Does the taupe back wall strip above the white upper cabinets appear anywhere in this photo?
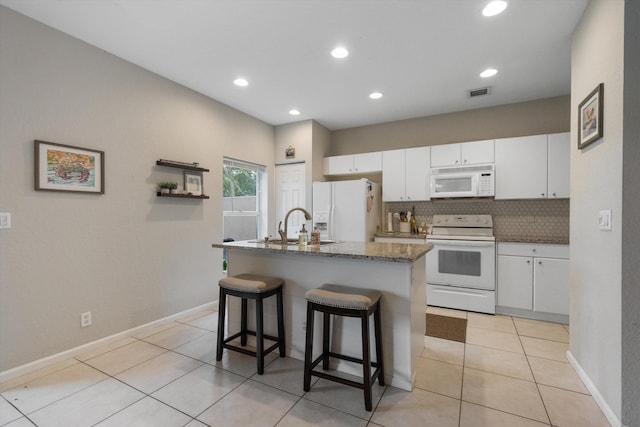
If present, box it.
[328,95,570,156]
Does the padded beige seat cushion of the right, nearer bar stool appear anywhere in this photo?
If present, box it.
[305,283,382,310]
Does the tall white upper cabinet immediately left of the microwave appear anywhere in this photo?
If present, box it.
[382,147,431,202]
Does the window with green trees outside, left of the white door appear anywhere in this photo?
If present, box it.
[222,157,267,241]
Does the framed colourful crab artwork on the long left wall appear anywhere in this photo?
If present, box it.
[34,140,104,194]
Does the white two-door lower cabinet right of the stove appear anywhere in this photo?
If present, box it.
[497,242,569,316]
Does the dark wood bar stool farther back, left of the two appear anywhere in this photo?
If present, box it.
[216,274,285,375]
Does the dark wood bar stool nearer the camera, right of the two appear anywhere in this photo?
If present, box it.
[304,284,385,411]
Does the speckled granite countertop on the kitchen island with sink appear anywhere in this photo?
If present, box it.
[211,240,433,263]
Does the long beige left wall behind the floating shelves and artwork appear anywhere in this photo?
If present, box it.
[0,6,274,371]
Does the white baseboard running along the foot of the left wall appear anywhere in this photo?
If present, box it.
[0,300,218,384]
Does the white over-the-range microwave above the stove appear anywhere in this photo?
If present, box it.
[430,165,495,199]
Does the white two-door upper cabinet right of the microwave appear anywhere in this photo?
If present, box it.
[495,133,570,199]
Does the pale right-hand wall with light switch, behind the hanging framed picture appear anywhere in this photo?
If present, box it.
[570,0,620,425]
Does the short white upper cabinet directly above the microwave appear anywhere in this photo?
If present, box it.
[431,139,494,168]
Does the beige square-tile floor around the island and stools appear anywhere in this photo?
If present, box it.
[0,307,609,427]
